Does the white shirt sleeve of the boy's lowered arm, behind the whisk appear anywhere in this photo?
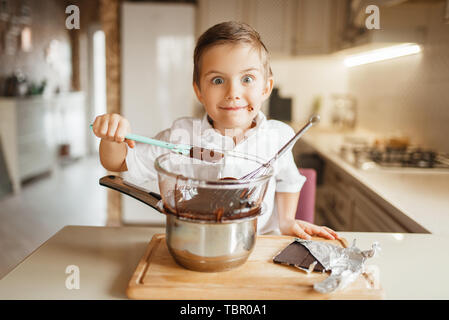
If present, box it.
[275,126,306,193]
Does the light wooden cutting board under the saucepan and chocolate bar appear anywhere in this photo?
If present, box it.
[126,234,384,300]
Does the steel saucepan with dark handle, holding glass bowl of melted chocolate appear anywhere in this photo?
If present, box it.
[100,154,272,272]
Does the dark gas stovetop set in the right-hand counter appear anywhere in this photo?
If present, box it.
[340,145,449,170]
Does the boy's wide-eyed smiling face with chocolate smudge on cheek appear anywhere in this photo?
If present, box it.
[193,44,273,133]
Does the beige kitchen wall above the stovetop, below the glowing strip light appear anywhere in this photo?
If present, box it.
[347,3,449,152]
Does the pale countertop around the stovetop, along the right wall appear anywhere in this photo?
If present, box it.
[302,128,449,235]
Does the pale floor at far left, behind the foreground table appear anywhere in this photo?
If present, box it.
[0,157,107,279]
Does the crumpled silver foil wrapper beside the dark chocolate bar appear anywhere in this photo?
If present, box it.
[295,238,380,293]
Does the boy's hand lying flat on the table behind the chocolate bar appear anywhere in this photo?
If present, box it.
[280,220,340,240]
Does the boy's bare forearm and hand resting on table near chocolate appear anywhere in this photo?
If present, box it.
[275,192,340,240]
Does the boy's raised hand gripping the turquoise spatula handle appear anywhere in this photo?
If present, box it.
[92,113,135,148]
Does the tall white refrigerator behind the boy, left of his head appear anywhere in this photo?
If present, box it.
[121,2,195,225]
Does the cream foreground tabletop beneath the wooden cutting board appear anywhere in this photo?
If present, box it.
[0,226,449,299]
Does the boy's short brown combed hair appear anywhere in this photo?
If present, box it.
[193,21,273,87]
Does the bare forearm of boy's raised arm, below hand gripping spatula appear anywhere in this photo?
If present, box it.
[99,139,128,172]
